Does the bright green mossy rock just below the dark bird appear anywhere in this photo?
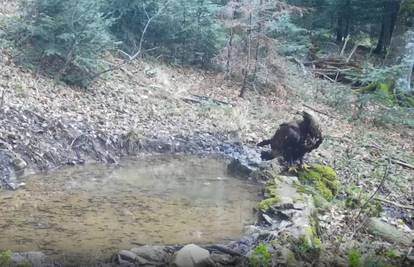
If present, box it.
[299,165,340,201]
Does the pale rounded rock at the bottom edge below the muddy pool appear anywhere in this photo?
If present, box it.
[171,244,215,267]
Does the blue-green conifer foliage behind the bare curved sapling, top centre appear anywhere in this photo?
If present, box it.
[106,0,226,66]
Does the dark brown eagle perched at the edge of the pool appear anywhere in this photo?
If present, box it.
[257,111,323,171]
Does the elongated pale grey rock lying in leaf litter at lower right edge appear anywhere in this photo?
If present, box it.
[368,218,414,246]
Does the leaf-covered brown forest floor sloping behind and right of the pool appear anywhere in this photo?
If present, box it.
[0,1,414,262]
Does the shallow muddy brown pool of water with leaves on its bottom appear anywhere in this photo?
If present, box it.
[0,157,260,257]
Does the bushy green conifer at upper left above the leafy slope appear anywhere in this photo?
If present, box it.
[8,0,114,86]
